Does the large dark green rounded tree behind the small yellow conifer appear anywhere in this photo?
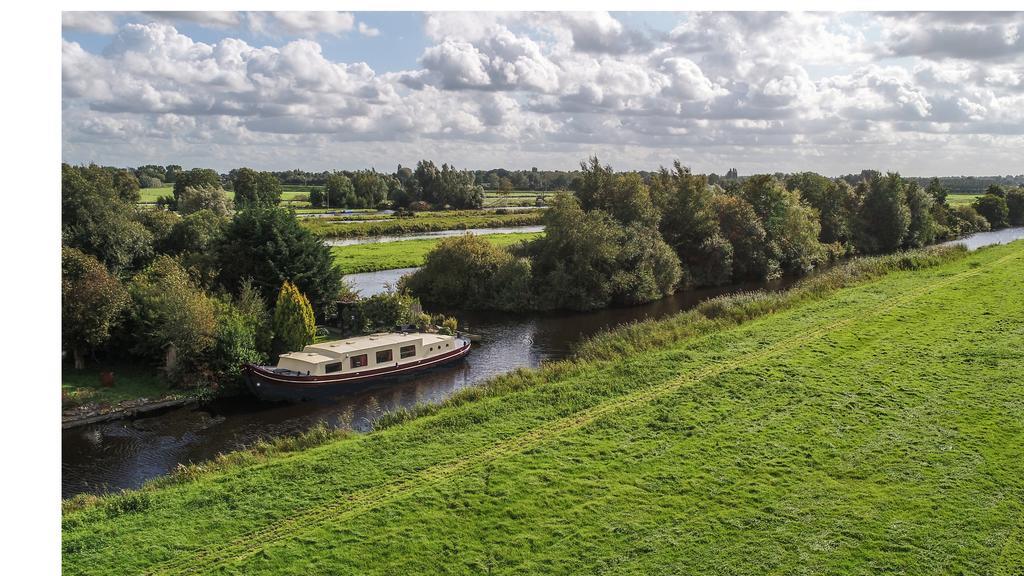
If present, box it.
[213,207,341,314]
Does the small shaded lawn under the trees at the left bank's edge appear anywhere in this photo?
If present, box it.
[60,365,180,408]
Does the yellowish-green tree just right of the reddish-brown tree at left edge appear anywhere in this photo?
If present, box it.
[131,255,217,383]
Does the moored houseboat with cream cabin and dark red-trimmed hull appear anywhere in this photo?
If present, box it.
[245,332,471,400]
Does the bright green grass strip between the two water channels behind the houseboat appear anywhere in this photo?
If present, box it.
[331,228,543,274]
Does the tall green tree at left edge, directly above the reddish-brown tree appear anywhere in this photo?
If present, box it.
[60,164,153,275]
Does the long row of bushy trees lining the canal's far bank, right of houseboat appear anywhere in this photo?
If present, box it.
[403,158,1024,311]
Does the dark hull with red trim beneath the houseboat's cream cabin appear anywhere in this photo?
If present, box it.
[245,338,471,401]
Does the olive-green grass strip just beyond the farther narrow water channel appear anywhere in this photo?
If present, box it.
[302,210,544,238]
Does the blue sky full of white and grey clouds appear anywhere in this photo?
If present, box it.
[61,12,1024,175]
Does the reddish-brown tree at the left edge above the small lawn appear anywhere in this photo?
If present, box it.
[60,247,128,369]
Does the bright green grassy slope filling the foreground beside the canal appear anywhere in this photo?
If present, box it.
[63,242,1024,574]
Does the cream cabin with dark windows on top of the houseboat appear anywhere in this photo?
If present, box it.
[278,332,459,376]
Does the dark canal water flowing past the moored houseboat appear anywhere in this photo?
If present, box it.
[61,228,1024,497]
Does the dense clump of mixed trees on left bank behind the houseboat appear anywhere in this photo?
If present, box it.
[61,164,351,387]
